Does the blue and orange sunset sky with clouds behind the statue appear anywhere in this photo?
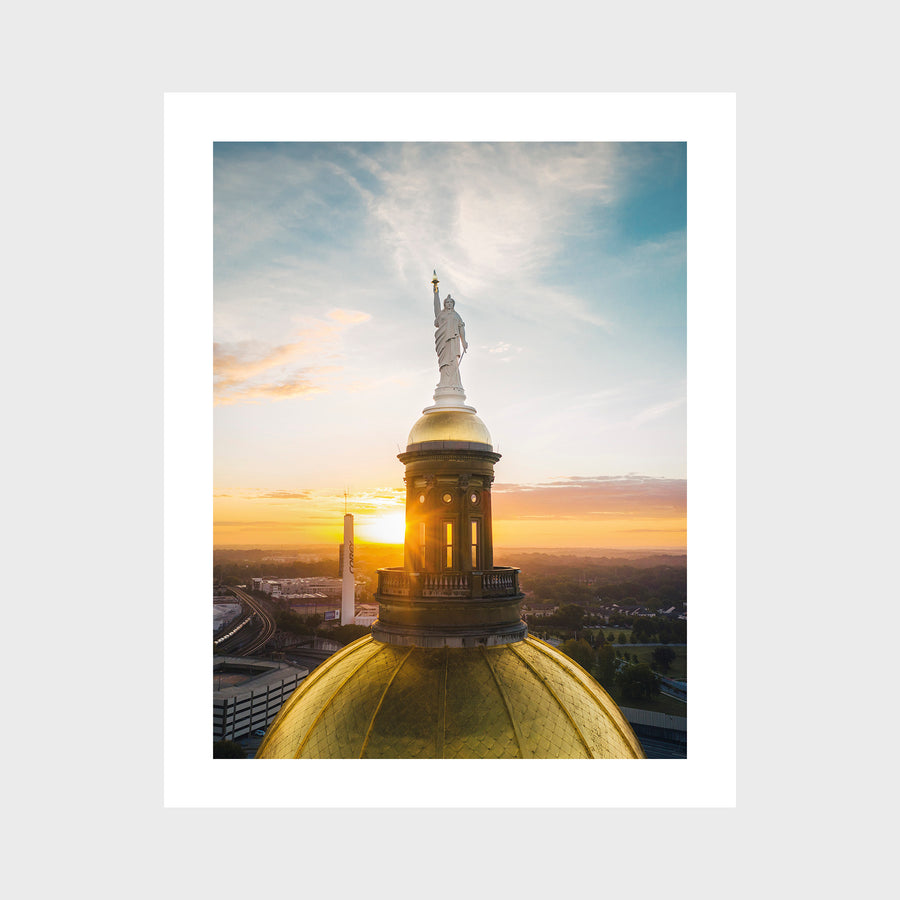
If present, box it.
[213,142,687,550]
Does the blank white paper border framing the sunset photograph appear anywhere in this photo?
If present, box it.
[164,93,736,807]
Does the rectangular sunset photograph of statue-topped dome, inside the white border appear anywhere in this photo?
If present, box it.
[210,140,691,760]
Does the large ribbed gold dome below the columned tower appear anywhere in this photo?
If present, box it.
[256,635,644,759]
